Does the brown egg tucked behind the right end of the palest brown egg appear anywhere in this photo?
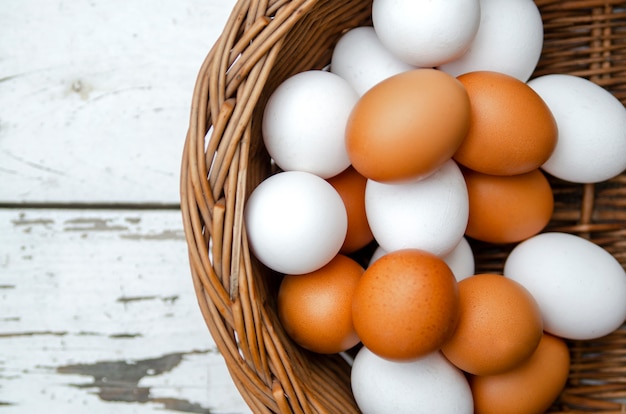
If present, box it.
[454,71,557,175]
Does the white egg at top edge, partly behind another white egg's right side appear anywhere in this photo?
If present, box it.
[439,0,543,82]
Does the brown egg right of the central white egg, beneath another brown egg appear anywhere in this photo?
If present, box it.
[462,169,554,243]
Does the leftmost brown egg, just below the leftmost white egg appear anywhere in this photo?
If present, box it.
[277,255,363,354]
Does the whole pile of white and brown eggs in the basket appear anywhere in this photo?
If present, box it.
[244,0,626,414]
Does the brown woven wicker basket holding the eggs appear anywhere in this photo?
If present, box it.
[181,0,626,413]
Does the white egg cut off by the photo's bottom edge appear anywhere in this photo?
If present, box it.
[351,347,474,414]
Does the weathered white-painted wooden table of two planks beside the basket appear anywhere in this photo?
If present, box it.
[0,0,249,414]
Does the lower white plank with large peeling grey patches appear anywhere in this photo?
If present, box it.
[0,209,249,414]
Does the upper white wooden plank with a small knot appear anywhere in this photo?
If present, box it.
[0,0,235,205]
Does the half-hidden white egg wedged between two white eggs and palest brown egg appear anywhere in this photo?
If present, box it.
[330,26,415,95]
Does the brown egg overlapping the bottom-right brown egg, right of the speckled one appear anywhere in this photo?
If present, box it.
[442,274,543,375]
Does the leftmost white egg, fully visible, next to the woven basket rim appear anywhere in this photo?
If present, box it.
[244,171,348,274]
